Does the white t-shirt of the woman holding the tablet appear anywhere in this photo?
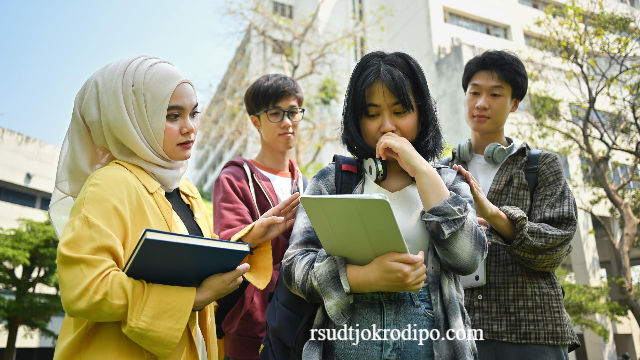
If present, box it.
[364,172,429,262]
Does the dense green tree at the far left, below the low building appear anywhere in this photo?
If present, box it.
[0,219,62,360]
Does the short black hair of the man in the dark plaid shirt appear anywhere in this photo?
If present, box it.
[462,50,529,101]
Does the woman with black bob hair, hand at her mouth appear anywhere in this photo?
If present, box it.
[282,52,487,360]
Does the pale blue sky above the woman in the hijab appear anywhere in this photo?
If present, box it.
[0,0,243,146]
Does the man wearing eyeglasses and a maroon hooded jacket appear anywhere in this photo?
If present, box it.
[213,74,307,360]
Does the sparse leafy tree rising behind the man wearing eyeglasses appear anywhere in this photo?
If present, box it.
[228,0,389,176]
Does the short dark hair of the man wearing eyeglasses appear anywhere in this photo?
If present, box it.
[244,74,304,115]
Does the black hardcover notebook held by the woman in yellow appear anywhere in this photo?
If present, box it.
[124,229,249,287]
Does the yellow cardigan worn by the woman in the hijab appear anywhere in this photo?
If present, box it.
[54,161,272,360]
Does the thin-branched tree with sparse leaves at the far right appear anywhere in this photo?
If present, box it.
[519,0,640,332]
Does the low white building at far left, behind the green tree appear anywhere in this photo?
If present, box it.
[0,128,64,360]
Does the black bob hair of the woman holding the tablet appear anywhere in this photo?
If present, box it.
[341,51,443,161]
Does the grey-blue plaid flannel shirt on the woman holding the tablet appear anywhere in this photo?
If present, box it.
[281,164,487,360]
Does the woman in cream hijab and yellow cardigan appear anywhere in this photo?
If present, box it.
[49,57,299,360]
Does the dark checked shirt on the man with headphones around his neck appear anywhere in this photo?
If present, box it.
[454,143,580,351]
